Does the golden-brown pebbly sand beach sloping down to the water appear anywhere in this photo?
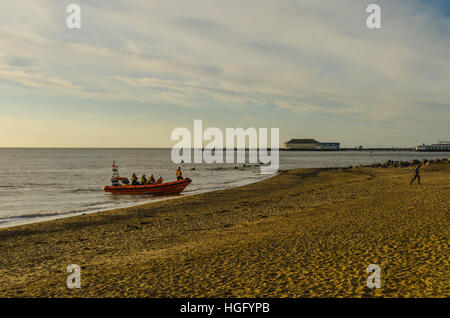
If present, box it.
[0,163,450,297]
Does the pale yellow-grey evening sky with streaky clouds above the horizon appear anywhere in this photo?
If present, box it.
[0,0,450,147]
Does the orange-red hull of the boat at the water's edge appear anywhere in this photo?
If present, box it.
[103,179,192,195]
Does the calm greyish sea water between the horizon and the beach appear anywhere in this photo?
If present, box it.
[0,148,449,227]
